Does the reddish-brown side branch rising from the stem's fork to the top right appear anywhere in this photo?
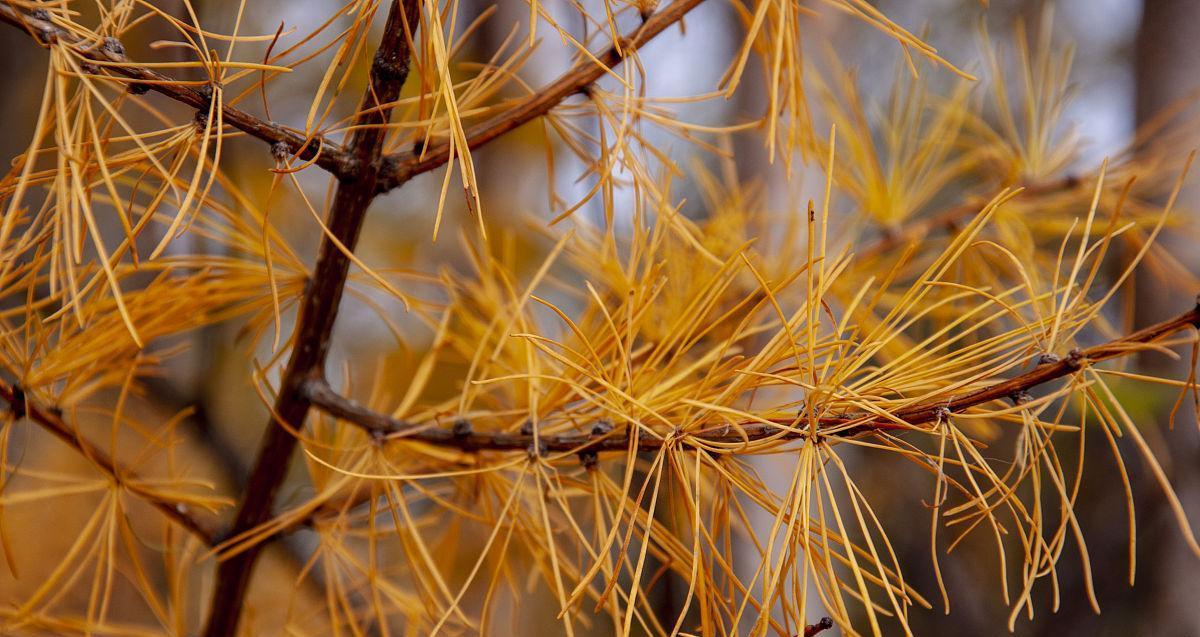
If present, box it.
[379,0,703,192]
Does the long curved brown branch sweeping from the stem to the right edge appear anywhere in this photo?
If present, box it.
[304,298,1200,453]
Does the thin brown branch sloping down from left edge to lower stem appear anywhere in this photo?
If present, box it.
[0,381,217,546]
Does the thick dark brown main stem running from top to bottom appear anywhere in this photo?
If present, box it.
[205,0,420,637]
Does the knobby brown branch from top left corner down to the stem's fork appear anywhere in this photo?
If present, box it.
[0,0,355,178]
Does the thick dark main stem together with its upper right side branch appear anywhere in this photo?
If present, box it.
[205,0,701,637]
